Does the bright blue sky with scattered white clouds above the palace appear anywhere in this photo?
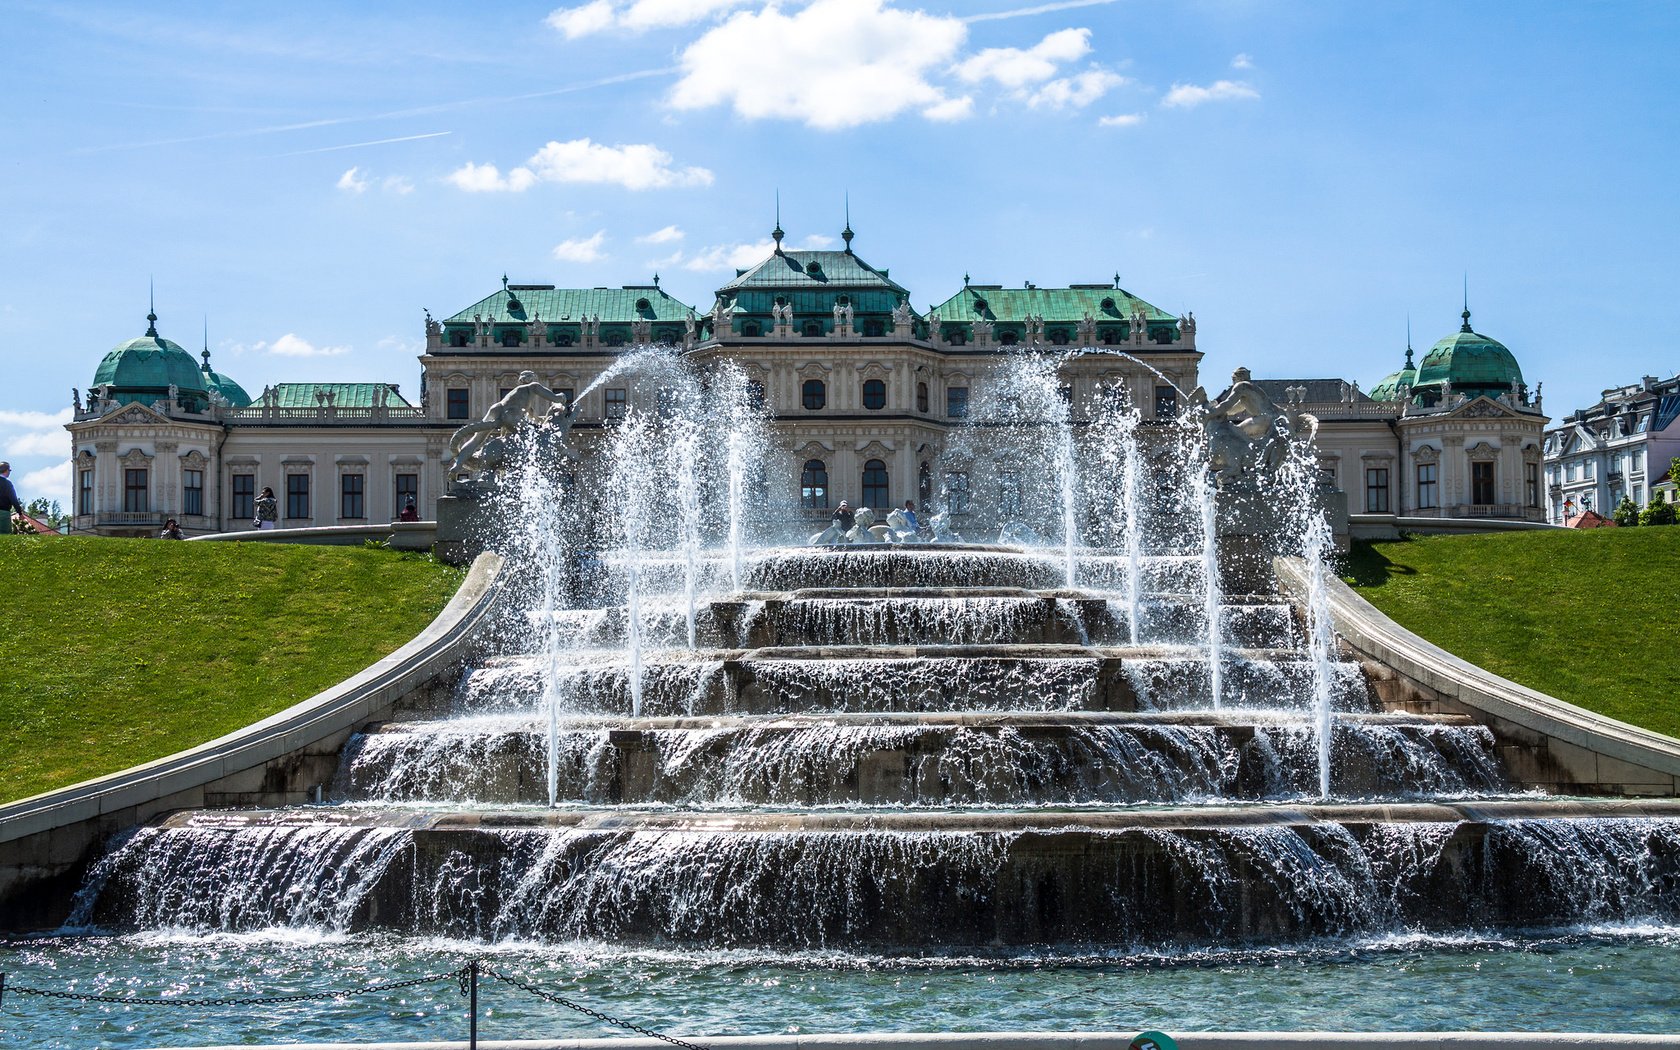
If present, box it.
[0,0,1680,506]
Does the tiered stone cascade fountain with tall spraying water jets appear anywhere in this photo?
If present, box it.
[13,351,1680,1032]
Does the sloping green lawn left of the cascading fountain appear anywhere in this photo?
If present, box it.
[0,536,464,801]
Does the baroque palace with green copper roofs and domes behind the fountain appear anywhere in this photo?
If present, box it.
[67,227,1544,536]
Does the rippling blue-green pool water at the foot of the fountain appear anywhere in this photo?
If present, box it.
[0,924,1680,1048]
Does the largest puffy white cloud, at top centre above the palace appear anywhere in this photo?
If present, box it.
[670,0,968,129]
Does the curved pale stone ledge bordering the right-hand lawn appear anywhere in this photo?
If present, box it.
[1277,558,1680,795]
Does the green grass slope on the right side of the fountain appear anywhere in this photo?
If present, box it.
[1342,526,1680,736]
